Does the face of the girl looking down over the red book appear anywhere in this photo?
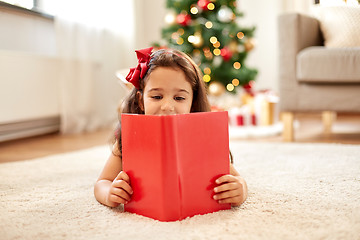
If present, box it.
[143,67,193,115]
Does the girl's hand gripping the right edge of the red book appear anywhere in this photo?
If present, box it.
[213,174,247,206]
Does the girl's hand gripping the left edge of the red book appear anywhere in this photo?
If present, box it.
[107,171,133,206]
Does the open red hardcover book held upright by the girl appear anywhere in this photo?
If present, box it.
[121,112,230,221]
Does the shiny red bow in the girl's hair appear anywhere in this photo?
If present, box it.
[126,47,153,89]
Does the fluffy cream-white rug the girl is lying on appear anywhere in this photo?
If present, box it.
[0,142,360,240]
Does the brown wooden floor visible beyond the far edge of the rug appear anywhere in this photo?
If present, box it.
[0,114,360,163]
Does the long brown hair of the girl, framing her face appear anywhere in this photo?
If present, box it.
[116,49,210,156]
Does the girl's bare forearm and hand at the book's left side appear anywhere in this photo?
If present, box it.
[94,143,132,207]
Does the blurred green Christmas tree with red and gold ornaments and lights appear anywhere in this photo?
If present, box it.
[154,0,257,92]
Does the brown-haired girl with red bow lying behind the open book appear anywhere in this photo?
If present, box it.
[94,48,247,207]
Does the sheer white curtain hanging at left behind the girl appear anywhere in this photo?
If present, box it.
[45,0,134,133]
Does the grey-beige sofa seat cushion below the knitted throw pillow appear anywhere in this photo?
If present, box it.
[296,46,360,83]
